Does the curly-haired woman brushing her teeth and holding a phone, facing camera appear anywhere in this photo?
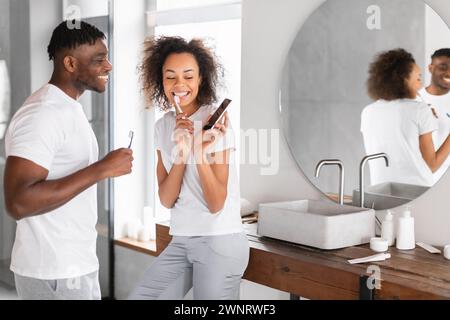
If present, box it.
[130,37,249,299]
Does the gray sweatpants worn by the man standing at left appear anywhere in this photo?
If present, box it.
[14,271,101,300]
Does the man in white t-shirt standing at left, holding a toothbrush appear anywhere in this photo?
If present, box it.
[4,22,133,299]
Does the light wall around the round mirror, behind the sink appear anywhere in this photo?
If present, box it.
[241,0,450,245]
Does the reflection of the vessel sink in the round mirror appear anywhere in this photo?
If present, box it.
[353,182,430,210]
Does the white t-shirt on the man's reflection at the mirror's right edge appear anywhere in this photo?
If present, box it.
[418,88,450,182]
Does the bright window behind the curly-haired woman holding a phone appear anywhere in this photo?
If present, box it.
[147,0,241,220]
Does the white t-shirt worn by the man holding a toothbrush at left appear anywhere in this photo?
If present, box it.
[5,84,99,280]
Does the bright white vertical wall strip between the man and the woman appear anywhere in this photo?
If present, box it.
[113,0,153,238]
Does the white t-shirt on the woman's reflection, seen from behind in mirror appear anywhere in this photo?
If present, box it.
[361,99,437,186]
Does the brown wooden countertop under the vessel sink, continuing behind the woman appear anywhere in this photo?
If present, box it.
[116,219,450,299]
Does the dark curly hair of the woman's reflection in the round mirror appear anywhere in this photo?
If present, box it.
[367,49,416,101]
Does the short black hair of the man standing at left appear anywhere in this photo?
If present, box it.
[47,21,106,60]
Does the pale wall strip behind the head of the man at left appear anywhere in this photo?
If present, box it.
[30,0,62,92]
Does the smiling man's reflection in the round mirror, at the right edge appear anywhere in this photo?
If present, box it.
[419,48,450,182]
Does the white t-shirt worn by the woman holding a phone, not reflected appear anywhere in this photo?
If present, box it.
[155,106,243,236]
